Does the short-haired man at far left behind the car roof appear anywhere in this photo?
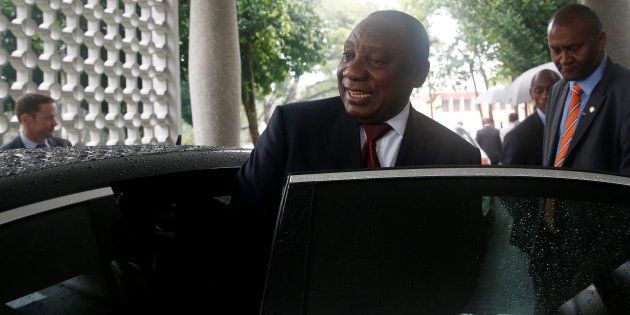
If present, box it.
[0,93,71,149]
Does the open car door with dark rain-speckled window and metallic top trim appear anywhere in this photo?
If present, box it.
[263,169,630,314]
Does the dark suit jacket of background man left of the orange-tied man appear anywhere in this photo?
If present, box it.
[501,112,545,166]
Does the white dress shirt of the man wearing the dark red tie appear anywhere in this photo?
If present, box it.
[360,104,411,167]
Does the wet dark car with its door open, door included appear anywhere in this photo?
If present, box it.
[0,146,630,314]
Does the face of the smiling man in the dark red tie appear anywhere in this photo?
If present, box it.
[337,16,429,123]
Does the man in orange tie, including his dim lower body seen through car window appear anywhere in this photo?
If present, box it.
[530,4,630,314]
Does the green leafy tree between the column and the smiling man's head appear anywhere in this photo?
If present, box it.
[237,0,324,95]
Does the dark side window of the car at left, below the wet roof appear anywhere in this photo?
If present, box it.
[0,197,131,314]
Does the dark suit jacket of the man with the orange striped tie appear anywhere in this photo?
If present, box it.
[543,59,630,175]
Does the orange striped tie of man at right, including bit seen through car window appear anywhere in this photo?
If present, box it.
[544,84,584,232]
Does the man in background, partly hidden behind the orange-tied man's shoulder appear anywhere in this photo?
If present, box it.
[501,69,560,166]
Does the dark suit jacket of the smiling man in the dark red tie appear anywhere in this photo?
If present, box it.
[236,97,481,226]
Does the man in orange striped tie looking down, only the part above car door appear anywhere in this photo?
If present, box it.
[543,4,630,175]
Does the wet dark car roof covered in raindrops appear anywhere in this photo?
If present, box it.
[0,145,249,211]
